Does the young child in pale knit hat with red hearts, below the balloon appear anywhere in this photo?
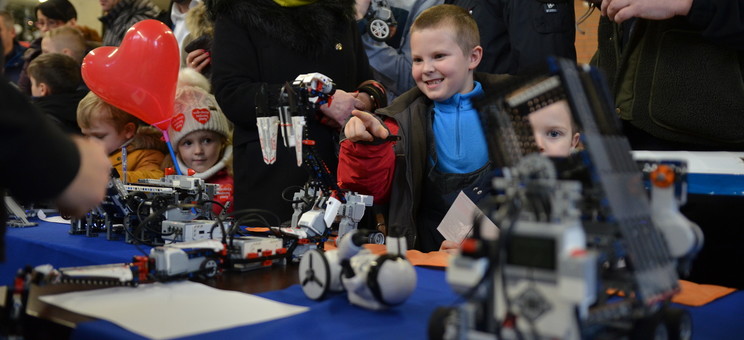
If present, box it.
[163,68,233,213]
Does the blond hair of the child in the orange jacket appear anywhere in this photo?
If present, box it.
[77,91,142,131]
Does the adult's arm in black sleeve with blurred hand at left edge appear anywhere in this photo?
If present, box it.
[0,80,111,216]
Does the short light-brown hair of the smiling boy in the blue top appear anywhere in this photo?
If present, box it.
[411,5,480,54]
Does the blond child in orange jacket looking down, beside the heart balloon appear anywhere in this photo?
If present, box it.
[77,92,167,183]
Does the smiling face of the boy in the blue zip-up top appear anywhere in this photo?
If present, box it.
[411,25,483,101]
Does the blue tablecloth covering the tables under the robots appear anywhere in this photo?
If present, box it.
[0,222,744,340]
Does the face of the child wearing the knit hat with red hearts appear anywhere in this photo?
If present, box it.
[178,130,223,173]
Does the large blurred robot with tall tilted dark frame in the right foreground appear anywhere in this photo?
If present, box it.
[429,59,702,339]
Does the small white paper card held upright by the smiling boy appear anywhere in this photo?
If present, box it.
[437,191,499,243]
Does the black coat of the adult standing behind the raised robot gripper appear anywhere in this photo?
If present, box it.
[206,0,372,220]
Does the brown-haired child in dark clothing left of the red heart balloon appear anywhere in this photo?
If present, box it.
[27,53,87,134]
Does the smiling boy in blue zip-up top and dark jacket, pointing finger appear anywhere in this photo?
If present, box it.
[338,5,508,251]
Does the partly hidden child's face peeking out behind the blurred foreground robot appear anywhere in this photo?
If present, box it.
[529,100,579,157]
